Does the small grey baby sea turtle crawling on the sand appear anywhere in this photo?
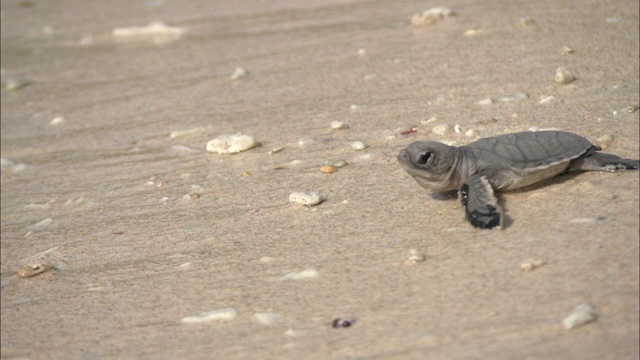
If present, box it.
[398,131,640,229]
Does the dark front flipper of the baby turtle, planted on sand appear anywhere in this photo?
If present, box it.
[458,173,502,229]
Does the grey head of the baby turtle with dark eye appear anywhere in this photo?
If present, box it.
[398,141,459,192]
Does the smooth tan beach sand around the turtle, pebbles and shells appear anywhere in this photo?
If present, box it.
[0,0,640,359]
